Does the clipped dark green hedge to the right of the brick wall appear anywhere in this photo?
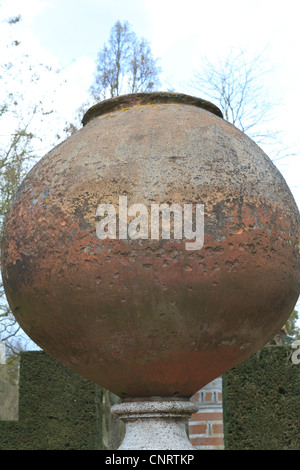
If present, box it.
[223,346,300,450]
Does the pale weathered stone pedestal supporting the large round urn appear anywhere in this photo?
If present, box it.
[111,398,198,450]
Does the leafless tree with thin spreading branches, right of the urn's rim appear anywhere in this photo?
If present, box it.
[192,50,279,151]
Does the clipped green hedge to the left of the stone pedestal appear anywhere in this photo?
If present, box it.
[0,351,123,450]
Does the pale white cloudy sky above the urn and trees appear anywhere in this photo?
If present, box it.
[0,0,300,322]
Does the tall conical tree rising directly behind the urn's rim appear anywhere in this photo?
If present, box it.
[90,21,161,100]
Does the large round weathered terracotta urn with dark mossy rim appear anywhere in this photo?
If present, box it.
[2,92,299,398]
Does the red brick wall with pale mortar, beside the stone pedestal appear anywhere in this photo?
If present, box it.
[189,377,224,450]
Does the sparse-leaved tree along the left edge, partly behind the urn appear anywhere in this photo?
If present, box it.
[0,16,65,351]
